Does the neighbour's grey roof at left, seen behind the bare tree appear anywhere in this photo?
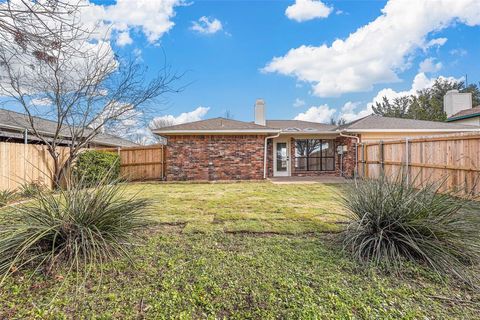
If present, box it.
[0,109,138,147]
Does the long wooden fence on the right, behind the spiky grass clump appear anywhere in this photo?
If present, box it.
[356,133,480,194]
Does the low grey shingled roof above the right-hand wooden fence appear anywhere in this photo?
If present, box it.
[337,115,480,132]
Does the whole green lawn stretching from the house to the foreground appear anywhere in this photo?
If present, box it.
[0,183,480,319]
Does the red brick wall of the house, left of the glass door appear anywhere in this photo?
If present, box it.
[166,135,265,181]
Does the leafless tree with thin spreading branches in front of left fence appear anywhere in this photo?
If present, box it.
[0,0,179,187]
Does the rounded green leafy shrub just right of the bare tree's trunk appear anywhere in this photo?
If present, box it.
[74,150,120,185]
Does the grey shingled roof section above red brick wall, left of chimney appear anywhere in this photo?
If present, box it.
[153,118,278,135]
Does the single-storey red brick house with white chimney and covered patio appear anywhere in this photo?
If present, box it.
[154,100,480,181]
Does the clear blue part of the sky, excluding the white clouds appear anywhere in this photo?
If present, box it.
[120,1,480,125]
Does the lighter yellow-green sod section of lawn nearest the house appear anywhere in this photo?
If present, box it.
[135,183,343,234]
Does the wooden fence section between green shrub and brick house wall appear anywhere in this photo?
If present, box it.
[99,144,166,181]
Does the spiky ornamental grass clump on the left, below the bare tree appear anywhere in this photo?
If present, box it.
[0,172,148,278]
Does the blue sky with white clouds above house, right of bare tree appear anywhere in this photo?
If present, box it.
[8,0,480,127]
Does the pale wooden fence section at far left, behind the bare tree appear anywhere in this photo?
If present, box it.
[0,142,68,190]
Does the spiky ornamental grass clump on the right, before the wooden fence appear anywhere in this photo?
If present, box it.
[341,174,480,282]
